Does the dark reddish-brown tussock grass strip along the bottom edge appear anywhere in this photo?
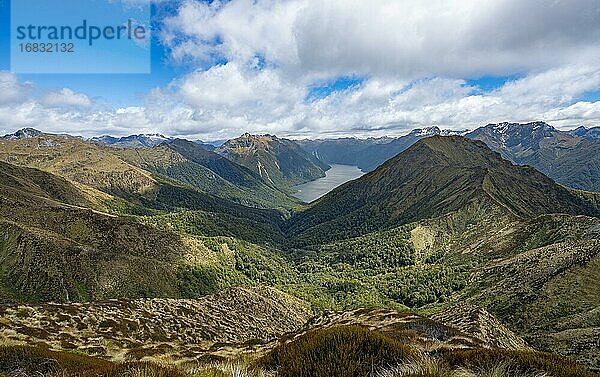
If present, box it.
[0,336,599,377]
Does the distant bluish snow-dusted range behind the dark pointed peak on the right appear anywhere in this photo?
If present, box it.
[298,122,600,191]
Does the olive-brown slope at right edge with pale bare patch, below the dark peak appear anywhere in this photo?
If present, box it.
[413,210,600,369]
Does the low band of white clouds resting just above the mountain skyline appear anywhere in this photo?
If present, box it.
[0,62,600,140]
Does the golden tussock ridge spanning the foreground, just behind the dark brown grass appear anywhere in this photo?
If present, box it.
[0,298,516,363]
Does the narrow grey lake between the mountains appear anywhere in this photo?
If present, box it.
[294,164,365,203]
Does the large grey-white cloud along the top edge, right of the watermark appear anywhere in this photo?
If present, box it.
[164,0,600,79]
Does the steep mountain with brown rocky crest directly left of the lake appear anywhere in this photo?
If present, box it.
[216,134,329,190]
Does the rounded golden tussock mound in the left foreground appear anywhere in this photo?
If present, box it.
[0,287,311,362]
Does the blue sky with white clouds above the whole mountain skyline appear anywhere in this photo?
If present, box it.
[0,0,600,140]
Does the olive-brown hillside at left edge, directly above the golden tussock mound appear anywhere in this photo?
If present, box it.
[0,163,294,302]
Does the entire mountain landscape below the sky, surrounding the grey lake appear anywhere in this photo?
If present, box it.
[0,122,600,376]
